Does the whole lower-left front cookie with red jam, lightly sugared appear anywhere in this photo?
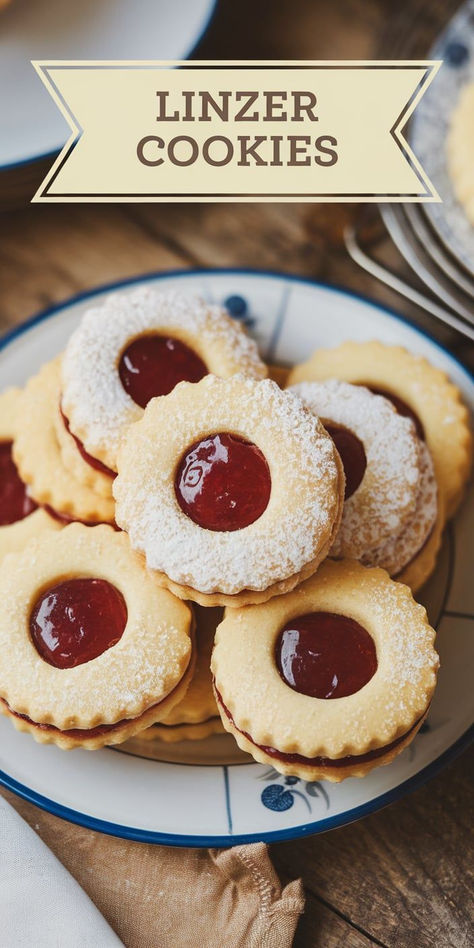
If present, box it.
[0,524,193,750]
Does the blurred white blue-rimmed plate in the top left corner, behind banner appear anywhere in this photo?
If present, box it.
[0,0,215,169]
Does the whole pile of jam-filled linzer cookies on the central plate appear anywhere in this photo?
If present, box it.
[0,288,471,781]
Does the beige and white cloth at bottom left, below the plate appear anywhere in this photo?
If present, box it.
[0,796,304,948]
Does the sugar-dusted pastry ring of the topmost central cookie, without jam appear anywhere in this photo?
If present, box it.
[114,375,341,595]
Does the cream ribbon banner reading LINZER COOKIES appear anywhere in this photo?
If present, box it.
[33,61,442,202]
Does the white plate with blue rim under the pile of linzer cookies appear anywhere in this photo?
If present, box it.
[0,270,474,846]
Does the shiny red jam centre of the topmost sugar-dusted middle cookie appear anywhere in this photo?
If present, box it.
[175,432,271,531]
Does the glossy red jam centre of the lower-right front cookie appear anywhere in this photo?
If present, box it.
[275,612,377,698]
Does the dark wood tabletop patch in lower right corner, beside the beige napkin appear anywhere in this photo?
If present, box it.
[272,753,474,948]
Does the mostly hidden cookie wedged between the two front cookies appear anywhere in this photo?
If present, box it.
[140,605,224,743]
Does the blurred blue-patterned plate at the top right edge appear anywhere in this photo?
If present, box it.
[410,0,474,274]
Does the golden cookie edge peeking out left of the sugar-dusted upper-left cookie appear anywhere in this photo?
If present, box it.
[13,359,115,523]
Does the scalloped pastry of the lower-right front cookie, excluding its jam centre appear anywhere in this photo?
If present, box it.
[211,560,439,782]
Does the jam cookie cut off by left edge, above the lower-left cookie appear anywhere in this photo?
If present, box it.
[0,388,60,560]
